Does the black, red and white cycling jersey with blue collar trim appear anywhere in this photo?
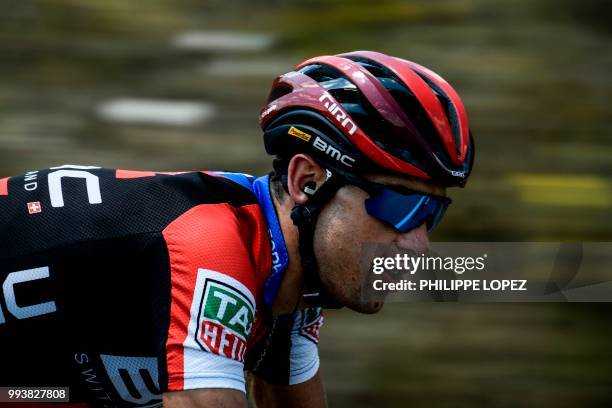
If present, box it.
[0,166,322,407]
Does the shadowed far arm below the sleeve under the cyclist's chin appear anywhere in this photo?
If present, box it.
[249,371,327,408]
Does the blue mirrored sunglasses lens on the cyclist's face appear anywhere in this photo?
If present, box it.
[365,188,450,233]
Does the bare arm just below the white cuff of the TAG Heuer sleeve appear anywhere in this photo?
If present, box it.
[163,388,247,408]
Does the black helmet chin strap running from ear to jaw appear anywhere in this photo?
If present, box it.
[291,172,345,309]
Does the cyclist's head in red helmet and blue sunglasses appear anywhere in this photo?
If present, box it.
[260,51,474,312]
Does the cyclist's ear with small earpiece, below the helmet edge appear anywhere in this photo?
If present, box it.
[287,153,326,204]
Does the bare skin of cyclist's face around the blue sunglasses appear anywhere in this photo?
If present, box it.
[314,175,445,313]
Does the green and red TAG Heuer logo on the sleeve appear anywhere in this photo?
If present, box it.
[196,269,255,362]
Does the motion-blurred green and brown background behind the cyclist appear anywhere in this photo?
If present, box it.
[0,0,612,408]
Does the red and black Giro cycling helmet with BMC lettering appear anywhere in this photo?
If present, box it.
[260,51,474,186]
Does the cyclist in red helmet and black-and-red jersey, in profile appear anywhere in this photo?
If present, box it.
[0,51,474,407]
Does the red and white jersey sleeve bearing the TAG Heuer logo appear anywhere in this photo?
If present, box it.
[163,203,267,392]
